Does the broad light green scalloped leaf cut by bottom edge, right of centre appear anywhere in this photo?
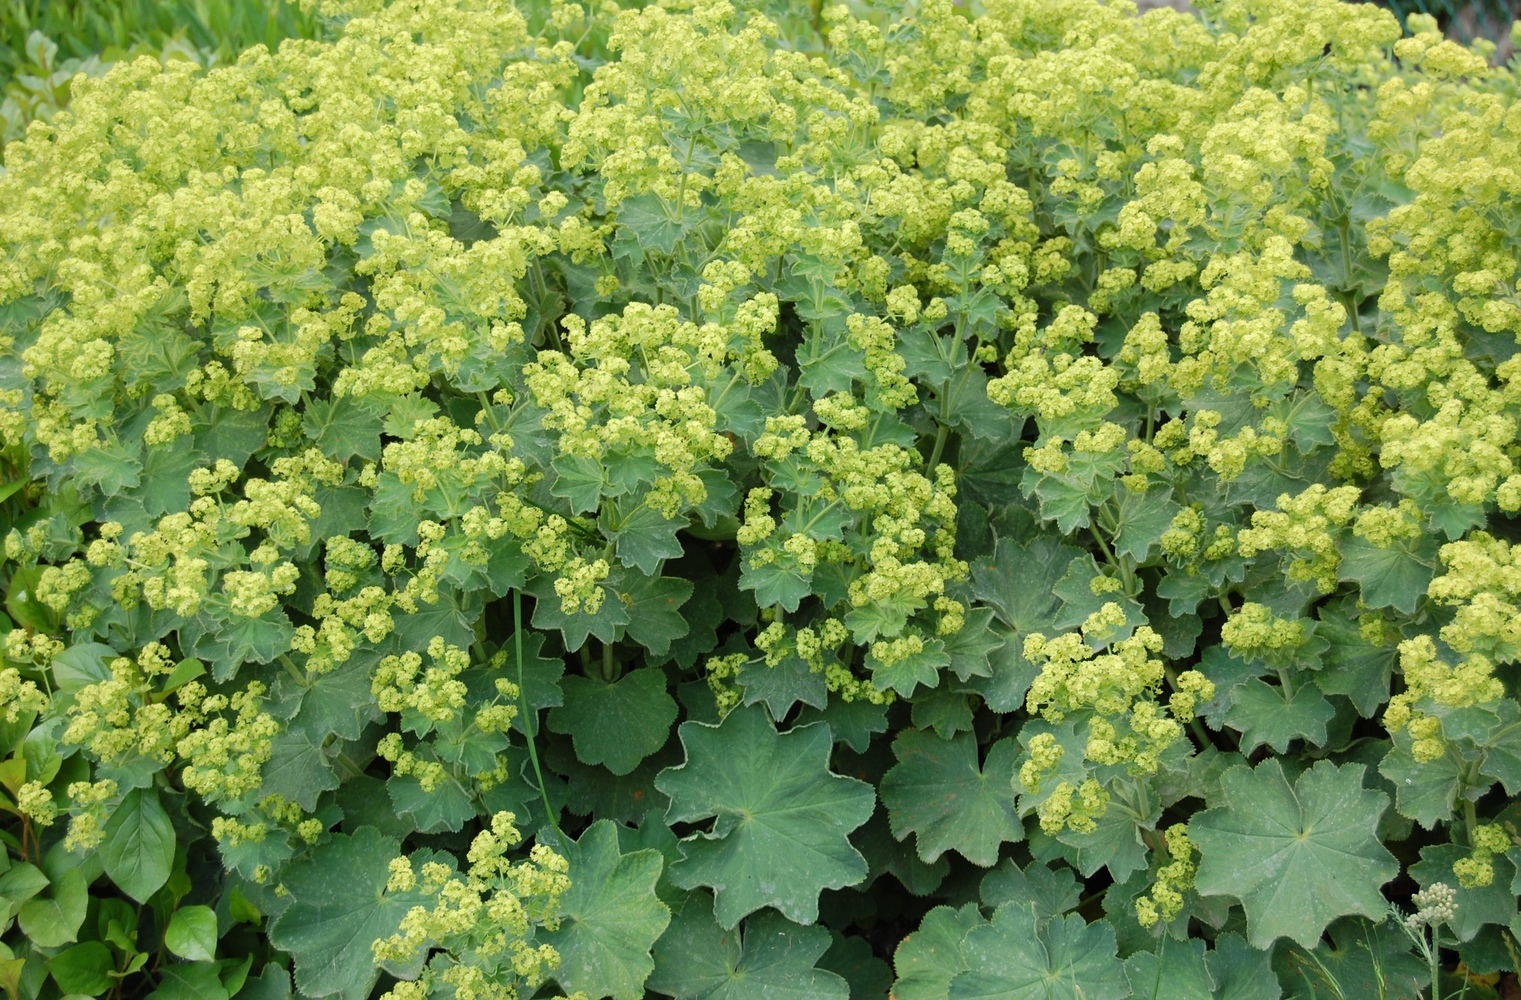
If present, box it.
[949,904,1130,1000]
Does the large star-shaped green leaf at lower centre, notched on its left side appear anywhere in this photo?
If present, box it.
[656,706,876,925]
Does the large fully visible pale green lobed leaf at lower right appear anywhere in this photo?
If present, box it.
[1188,760,1399,950]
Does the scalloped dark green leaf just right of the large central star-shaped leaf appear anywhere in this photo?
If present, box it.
[881,729,1025,868]
